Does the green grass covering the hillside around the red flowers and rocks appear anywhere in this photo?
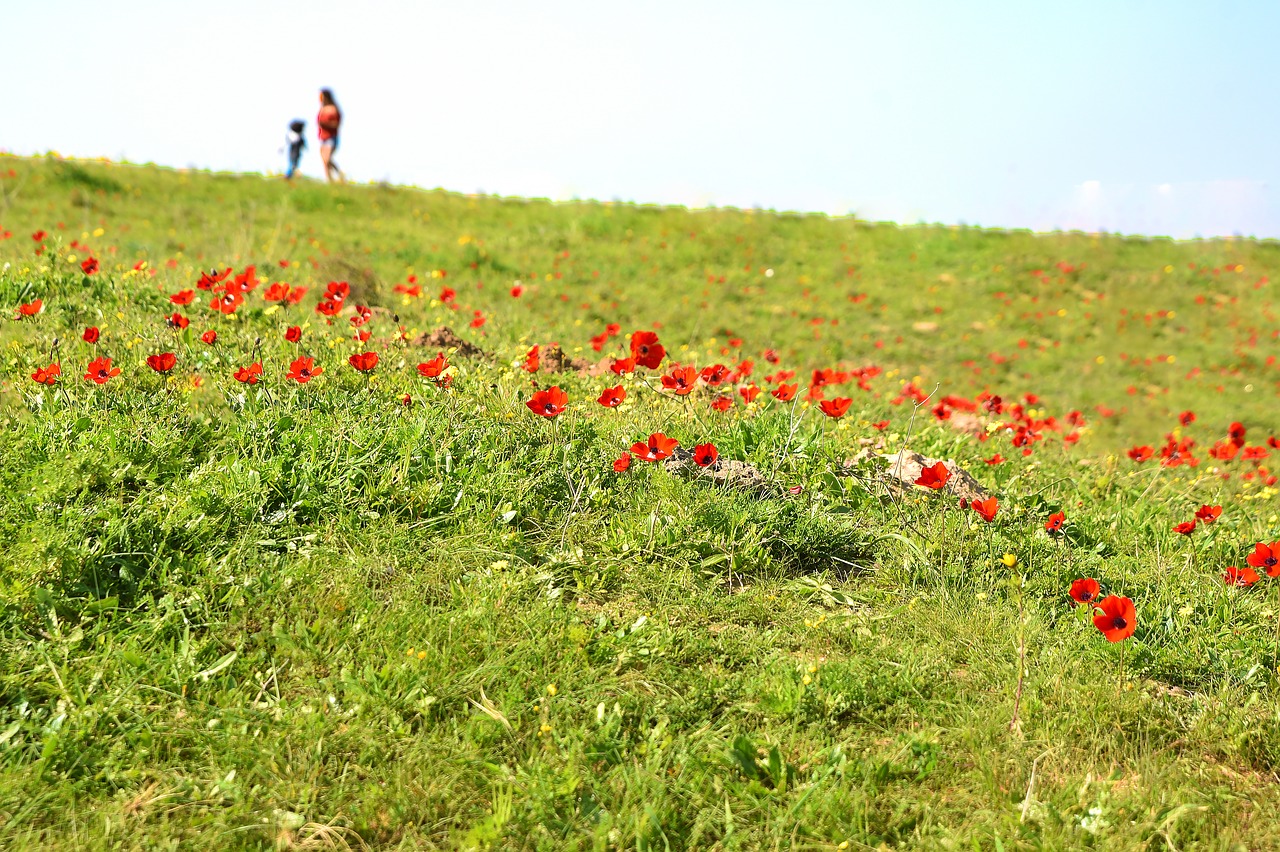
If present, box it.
[0,157,1280,849]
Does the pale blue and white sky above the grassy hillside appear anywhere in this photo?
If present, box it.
[0,0,1280,238]
